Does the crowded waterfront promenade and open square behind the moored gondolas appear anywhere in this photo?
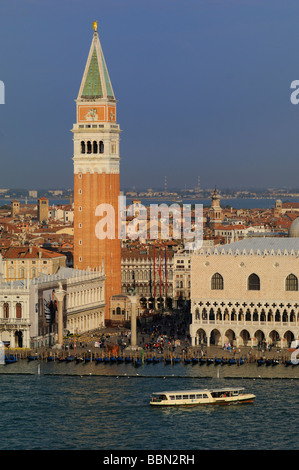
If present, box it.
[5,313,291,365]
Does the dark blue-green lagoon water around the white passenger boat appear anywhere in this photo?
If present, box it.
[0,361,299,451]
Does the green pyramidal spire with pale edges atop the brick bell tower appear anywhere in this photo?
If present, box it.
[78,27,115,100]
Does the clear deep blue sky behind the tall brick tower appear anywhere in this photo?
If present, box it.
[0,0,299,189]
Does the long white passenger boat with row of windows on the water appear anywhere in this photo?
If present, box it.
[150,388,255,406]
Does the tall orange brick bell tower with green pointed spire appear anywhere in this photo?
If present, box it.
[72,22,121,319]
